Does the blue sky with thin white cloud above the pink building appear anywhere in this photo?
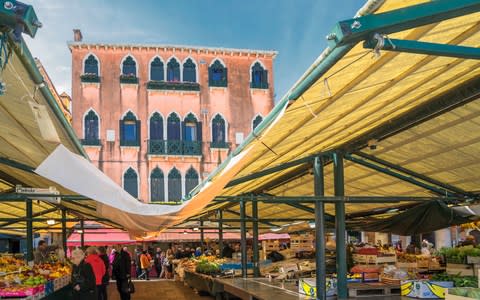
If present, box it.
[23,0,364,101]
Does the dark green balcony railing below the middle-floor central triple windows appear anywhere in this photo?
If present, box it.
[148,140,202,156]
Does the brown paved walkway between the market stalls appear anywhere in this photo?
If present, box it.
[108,279,213,300]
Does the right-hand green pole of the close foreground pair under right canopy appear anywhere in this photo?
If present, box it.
[333,152,348,299]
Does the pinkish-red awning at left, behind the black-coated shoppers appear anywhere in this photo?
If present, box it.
[67,228,136,247]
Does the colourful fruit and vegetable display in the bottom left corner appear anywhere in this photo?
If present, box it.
[0,256,71,297]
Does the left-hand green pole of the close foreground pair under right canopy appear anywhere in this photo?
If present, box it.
[313,157,327,300]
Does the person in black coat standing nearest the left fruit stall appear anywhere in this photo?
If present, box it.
[71,249,97,300]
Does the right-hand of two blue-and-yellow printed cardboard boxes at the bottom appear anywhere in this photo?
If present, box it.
[401,280,453,299]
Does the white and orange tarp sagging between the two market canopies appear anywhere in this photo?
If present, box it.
[35,145,249,232]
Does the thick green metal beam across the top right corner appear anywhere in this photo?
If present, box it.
[327,0,480,47]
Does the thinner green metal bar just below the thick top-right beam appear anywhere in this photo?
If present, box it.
[363,35,480,59]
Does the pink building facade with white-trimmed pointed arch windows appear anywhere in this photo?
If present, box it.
[69,32,276,202]
